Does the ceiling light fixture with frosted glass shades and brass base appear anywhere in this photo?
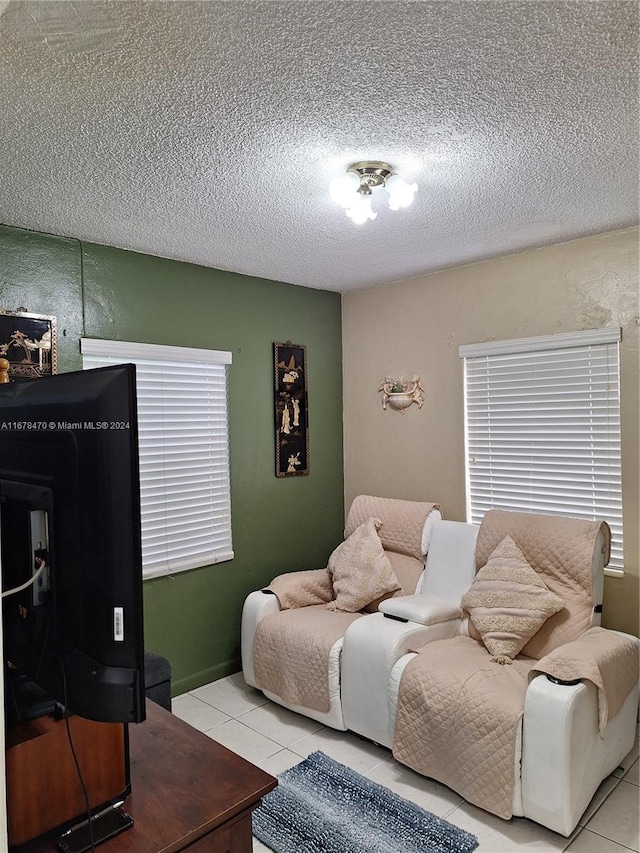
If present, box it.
[329,160,418,225]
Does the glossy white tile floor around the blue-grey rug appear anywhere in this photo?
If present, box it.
[173,673,640,853]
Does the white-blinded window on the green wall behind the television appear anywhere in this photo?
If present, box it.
[81,338,233,578]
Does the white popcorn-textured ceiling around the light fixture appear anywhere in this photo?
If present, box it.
[0,0,638,292]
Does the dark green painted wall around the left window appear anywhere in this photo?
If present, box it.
[0,226,344,695]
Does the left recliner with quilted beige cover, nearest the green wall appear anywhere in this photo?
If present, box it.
[241,495,441,730]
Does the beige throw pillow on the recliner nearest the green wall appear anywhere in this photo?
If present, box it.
[327,518,400,613]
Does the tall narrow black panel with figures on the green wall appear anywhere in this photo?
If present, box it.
[273,341,309,477]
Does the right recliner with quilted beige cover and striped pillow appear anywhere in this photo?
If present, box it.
[388,510,639,835]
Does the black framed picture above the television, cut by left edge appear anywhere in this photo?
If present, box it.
[0,309,58,382]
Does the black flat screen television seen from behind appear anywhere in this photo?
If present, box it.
[0,364,145,723]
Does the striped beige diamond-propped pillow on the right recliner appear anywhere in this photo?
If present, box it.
[461,536,564,664]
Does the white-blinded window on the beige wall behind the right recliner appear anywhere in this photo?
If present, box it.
[459,329,623,570]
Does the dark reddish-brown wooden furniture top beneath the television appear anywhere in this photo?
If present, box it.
[30,701,277,853]
